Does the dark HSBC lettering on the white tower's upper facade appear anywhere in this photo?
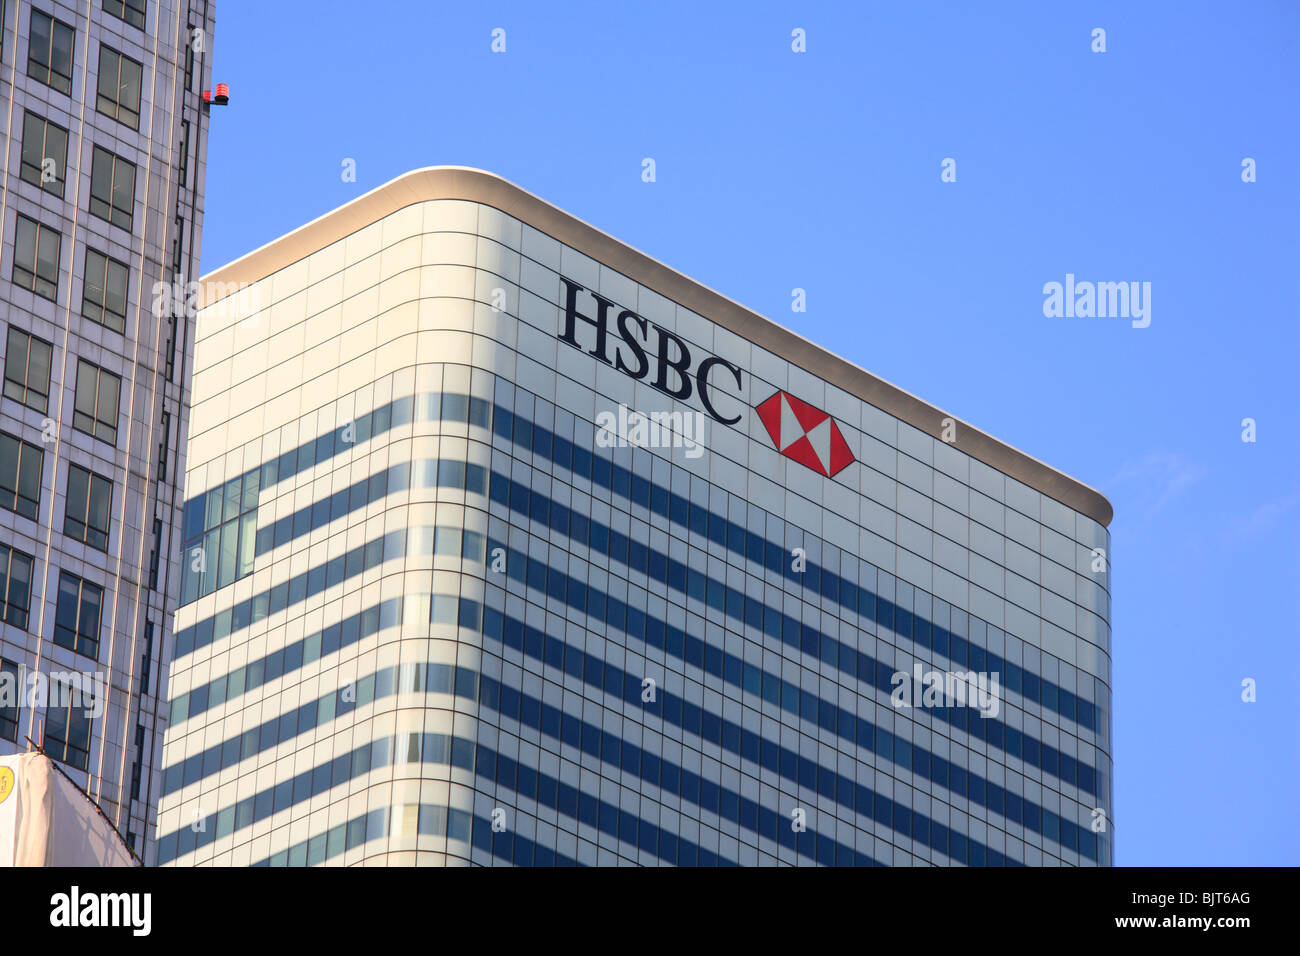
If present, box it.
[559,276,742,425]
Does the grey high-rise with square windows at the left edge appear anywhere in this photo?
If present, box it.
[0,0,215,862]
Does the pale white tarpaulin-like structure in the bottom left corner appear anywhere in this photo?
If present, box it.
[0,753,135,866]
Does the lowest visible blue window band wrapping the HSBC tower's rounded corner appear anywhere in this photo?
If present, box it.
[251,804,585,866]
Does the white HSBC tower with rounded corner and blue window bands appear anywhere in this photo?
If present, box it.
[159,168,1113,865]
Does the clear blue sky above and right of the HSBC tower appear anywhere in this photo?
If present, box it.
[203,0,1300,865]
